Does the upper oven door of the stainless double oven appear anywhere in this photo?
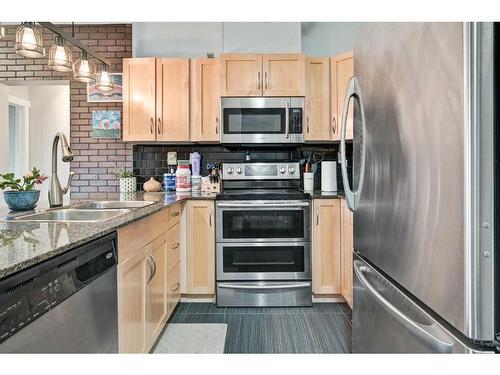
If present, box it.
[216,200,311,242]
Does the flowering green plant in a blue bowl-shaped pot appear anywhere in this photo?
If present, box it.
[0,167,48,211]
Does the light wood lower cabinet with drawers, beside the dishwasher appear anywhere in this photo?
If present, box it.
[117,203,181,353]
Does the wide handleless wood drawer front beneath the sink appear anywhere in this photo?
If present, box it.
[118,209,169,263]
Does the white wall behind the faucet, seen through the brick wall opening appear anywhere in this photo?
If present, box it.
[30,84,70,200]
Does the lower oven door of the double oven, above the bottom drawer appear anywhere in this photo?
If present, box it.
[216,242,311,281]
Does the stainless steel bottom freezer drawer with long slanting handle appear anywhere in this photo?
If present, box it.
[352,258,484,353]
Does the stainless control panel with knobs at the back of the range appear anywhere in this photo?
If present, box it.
[222,162,300,180]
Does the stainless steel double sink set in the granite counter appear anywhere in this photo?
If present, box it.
[12,201,156,223]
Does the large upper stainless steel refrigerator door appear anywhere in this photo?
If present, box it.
[348,23,493,340]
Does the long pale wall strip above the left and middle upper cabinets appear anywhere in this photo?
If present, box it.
[132,22,300,57]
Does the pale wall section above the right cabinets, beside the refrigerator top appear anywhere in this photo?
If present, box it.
[301,22,365,56]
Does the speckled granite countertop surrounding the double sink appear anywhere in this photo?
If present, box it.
[0,192,216,279]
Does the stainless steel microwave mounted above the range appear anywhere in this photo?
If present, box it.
[221,97,304,144]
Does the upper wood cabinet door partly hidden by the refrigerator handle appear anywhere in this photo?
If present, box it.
[330,52,354,140]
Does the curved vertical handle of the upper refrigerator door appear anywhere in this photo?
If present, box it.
[340,77,366,211]
